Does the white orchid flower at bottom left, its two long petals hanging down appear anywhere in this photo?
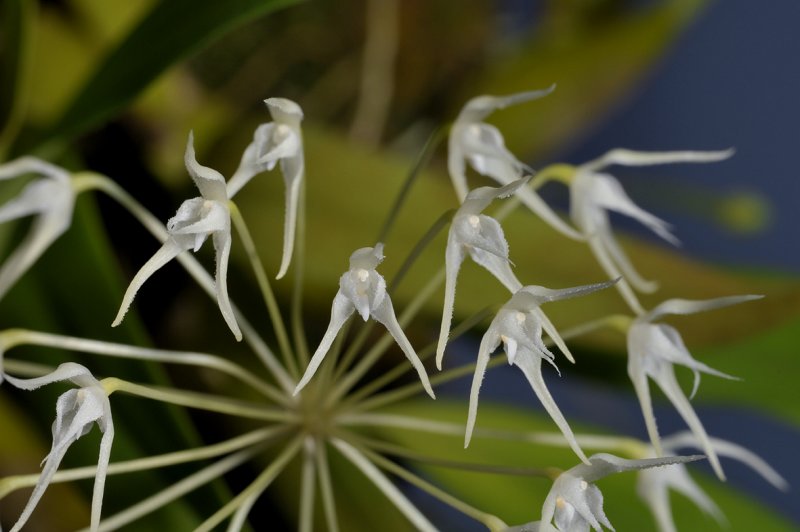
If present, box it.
[6,362,114,532]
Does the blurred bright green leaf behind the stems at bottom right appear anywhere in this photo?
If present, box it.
[379,400,794,531]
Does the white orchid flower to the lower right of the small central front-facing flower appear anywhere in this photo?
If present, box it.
[464,282,613,462]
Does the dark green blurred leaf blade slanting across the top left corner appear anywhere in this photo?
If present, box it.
[39,0,298,150]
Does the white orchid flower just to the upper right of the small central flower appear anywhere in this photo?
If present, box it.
[436,178,528,369]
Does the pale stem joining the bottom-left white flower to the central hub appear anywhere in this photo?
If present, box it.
[101,377,296,422]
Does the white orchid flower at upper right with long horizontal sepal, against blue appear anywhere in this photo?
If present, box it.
[570,149,733,314]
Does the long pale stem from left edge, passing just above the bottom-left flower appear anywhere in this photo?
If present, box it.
[0,329,287,404]
